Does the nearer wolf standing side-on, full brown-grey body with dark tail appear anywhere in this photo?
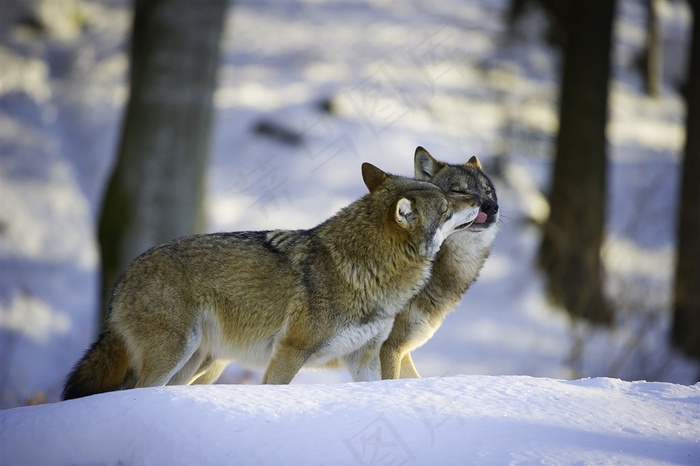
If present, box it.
[63,164,480,399]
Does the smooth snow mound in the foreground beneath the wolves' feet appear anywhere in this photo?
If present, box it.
[0,376,700,464]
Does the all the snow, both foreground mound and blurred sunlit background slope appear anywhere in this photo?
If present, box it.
[0,5,700,465]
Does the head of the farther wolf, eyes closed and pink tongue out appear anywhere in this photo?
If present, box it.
[414,147,499,233]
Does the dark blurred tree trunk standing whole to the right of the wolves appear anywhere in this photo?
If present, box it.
[539,0,615,324]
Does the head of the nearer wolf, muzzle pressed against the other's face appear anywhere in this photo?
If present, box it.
[362,163,478,256]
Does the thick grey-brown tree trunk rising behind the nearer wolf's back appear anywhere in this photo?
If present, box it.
[99,0,229,320]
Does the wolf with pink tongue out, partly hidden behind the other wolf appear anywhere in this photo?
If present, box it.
[381,147,499,379]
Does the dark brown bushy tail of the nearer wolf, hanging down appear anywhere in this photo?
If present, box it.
[62,330,129,400]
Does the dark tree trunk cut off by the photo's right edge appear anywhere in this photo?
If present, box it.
[671,0,700,358]
